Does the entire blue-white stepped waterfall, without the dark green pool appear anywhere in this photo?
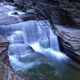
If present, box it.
[0,20,67,70]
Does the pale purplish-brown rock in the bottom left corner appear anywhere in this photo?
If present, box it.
[0,62,25,80]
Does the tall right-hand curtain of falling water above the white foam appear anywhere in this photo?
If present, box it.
[23,20,59,51]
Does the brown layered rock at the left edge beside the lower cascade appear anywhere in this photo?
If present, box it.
[0,36,10,66]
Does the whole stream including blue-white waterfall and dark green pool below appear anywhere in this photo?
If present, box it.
[0,3,80,80]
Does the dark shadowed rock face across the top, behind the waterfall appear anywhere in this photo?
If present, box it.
[14,0,80,28]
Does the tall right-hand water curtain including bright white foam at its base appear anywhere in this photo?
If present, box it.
[23,20,67,59]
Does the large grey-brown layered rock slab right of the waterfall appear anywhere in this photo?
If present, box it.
[56,25,80,62]
